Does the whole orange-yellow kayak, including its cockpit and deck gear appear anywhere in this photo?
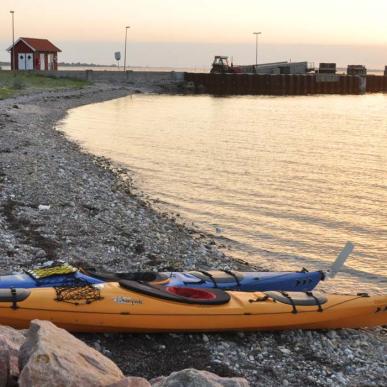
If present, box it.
[0,281,387,332]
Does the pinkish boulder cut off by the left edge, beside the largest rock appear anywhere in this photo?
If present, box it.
[0,325,26,387]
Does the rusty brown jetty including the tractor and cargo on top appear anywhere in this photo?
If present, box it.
[184,55,387,95]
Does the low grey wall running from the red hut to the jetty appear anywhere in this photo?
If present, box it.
[40,70,184,84]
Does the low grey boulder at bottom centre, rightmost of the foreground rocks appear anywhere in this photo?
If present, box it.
[150,368,249,387]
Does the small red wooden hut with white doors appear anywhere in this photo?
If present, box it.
[7,38,61,71]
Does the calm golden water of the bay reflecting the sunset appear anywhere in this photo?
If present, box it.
[60,94,387,292]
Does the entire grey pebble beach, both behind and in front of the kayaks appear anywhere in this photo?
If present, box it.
[0,84,387,386]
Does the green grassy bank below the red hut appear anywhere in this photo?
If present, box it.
[0,71,89,99]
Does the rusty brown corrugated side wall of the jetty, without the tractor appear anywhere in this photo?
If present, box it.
[184,73,387,95]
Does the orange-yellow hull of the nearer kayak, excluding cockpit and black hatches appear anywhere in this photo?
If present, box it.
[0,283,387,332]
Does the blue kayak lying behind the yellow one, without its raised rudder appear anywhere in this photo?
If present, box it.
[0,264,324,292]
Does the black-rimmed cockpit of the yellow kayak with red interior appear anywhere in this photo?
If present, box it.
[119,280,230,305]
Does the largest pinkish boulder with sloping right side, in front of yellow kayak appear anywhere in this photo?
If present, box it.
[19,320,124,387]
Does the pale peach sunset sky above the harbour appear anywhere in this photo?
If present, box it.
[0,0,387,68]
